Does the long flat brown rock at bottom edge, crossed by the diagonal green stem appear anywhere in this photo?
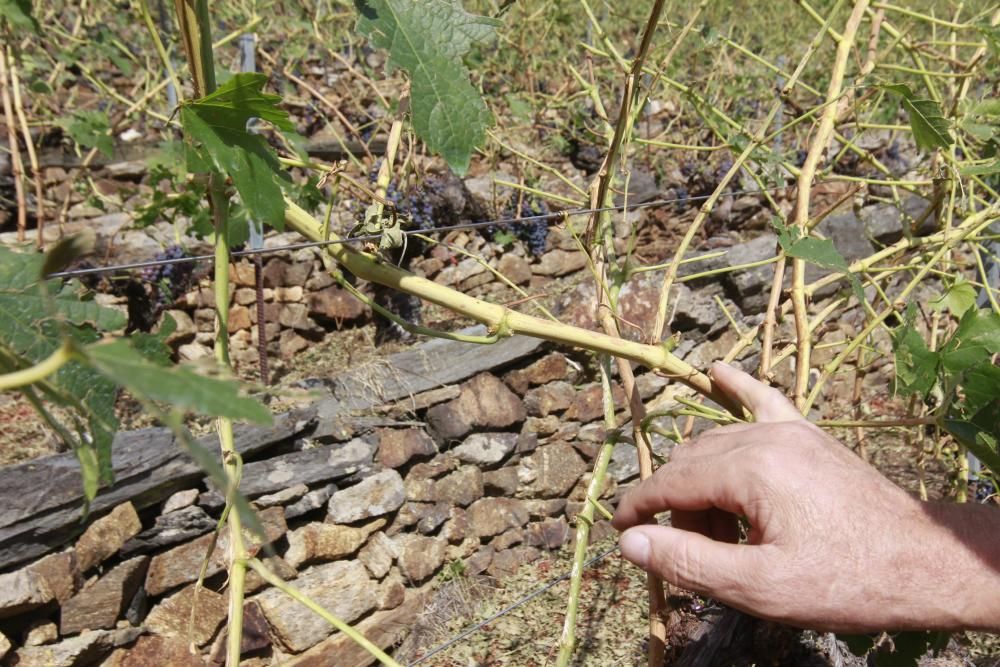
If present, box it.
[282,586,431,667]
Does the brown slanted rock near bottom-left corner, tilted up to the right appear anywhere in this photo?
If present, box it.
[59,556,149,635]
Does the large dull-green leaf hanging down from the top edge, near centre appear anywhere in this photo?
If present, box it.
[354,0,500,175]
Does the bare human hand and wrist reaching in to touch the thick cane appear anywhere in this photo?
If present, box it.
[613,364,1000,632]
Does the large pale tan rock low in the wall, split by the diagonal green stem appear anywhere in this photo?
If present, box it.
[254,561,378,664]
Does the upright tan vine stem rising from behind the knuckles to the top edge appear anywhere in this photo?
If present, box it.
[779,0,868,412]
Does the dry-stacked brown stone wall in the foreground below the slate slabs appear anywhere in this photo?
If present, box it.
[0,344,688,666]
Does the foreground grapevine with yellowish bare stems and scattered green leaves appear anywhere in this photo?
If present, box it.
[0,0,1000,665]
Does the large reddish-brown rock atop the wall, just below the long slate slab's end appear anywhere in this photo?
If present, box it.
[426,373,527,443]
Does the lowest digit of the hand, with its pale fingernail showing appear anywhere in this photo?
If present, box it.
[619,525,760,602]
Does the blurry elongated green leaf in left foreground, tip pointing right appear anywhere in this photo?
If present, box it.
[83,339,271,424]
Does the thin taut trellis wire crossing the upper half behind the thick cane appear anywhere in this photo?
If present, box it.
[47,185,789,278]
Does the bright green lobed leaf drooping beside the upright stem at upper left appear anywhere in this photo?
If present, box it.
[180,73,294,229]
